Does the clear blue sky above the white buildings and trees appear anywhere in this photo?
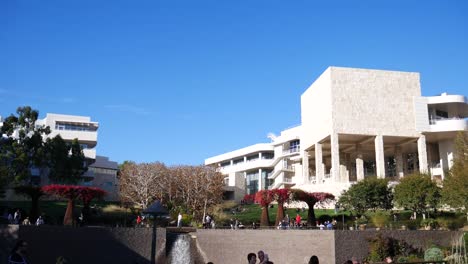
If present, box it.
[0,0,468,165]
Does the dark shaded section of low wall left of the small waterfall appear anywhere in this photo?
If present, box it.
[2,226,166,264]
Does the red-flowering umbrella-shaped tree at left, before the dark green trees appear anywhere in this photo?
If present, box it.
[42,184,105,225]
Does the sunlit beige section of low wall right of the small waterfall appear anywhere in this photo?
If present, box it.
[194,229,335,264]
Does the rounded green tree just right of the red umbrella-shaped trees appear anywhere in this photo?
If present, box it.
[338,177,393,215]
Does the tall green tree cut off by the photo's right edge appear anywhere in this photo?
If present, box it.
[442,131,468,219]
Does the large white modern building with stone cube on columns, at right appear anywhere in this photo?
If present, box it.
[205,67,468,200]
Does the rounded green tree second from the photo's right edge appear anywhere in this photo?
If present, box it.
[395,174,440,219]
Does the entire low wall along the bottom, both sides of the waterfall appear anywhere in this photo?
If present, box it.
[0,225,462,264]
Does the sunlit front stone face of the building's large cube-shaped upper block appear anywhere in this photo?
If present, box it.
[329,67,421,136]
